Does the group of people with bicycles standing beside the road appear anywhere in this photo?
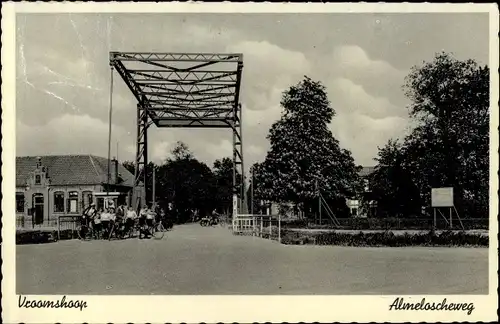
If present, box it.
[81,203,165,239]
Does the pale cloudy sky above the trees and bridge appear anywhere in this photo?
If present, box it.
[16,13,489,170]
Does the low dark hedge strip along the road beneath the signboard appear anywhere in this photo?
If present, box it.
[281,230,489,247]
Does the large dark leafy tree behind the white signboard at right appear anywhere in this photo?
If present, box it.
[370,53,489,217]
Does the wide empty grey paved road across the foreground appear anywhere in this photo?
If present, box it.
[16,225,488,295]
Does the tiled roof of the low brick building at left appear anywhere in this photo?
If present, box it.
[16,155,134,187]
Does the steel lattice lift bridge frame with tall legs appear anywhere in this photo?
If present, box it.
[109,52,246,212]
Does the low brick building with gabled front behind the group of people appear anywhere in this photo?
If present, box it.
[16,155,144,228]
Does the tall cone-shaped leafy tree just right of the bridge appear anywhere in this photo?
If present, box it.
[255,77,358,219]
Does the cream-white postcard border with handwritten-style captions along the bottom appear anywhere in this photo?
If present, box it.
[2,2,499,323]
